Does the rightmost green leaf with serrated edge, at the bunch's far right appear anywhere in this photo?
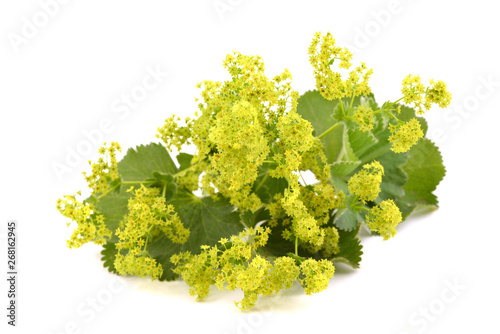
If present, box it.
[396,138,446,217]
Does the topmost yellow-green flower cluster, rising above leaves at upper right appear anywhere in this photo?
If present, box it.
[308,33,373,100]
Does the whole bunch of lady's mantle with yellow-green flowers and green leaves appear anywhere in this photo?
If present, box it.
[57,33,451,309]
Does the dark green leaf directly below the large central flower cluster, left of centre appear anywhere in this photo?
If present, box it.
[147,191,244,280]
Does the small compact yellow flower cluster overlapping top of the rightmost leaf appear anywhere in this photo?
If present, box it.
[389,118,424,153]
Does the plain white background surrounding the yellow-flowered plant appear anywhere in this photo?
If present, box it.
[0,0,500,334]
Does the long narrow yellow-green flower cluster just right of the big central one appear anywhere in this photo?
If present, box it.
[269,111,339,251]
